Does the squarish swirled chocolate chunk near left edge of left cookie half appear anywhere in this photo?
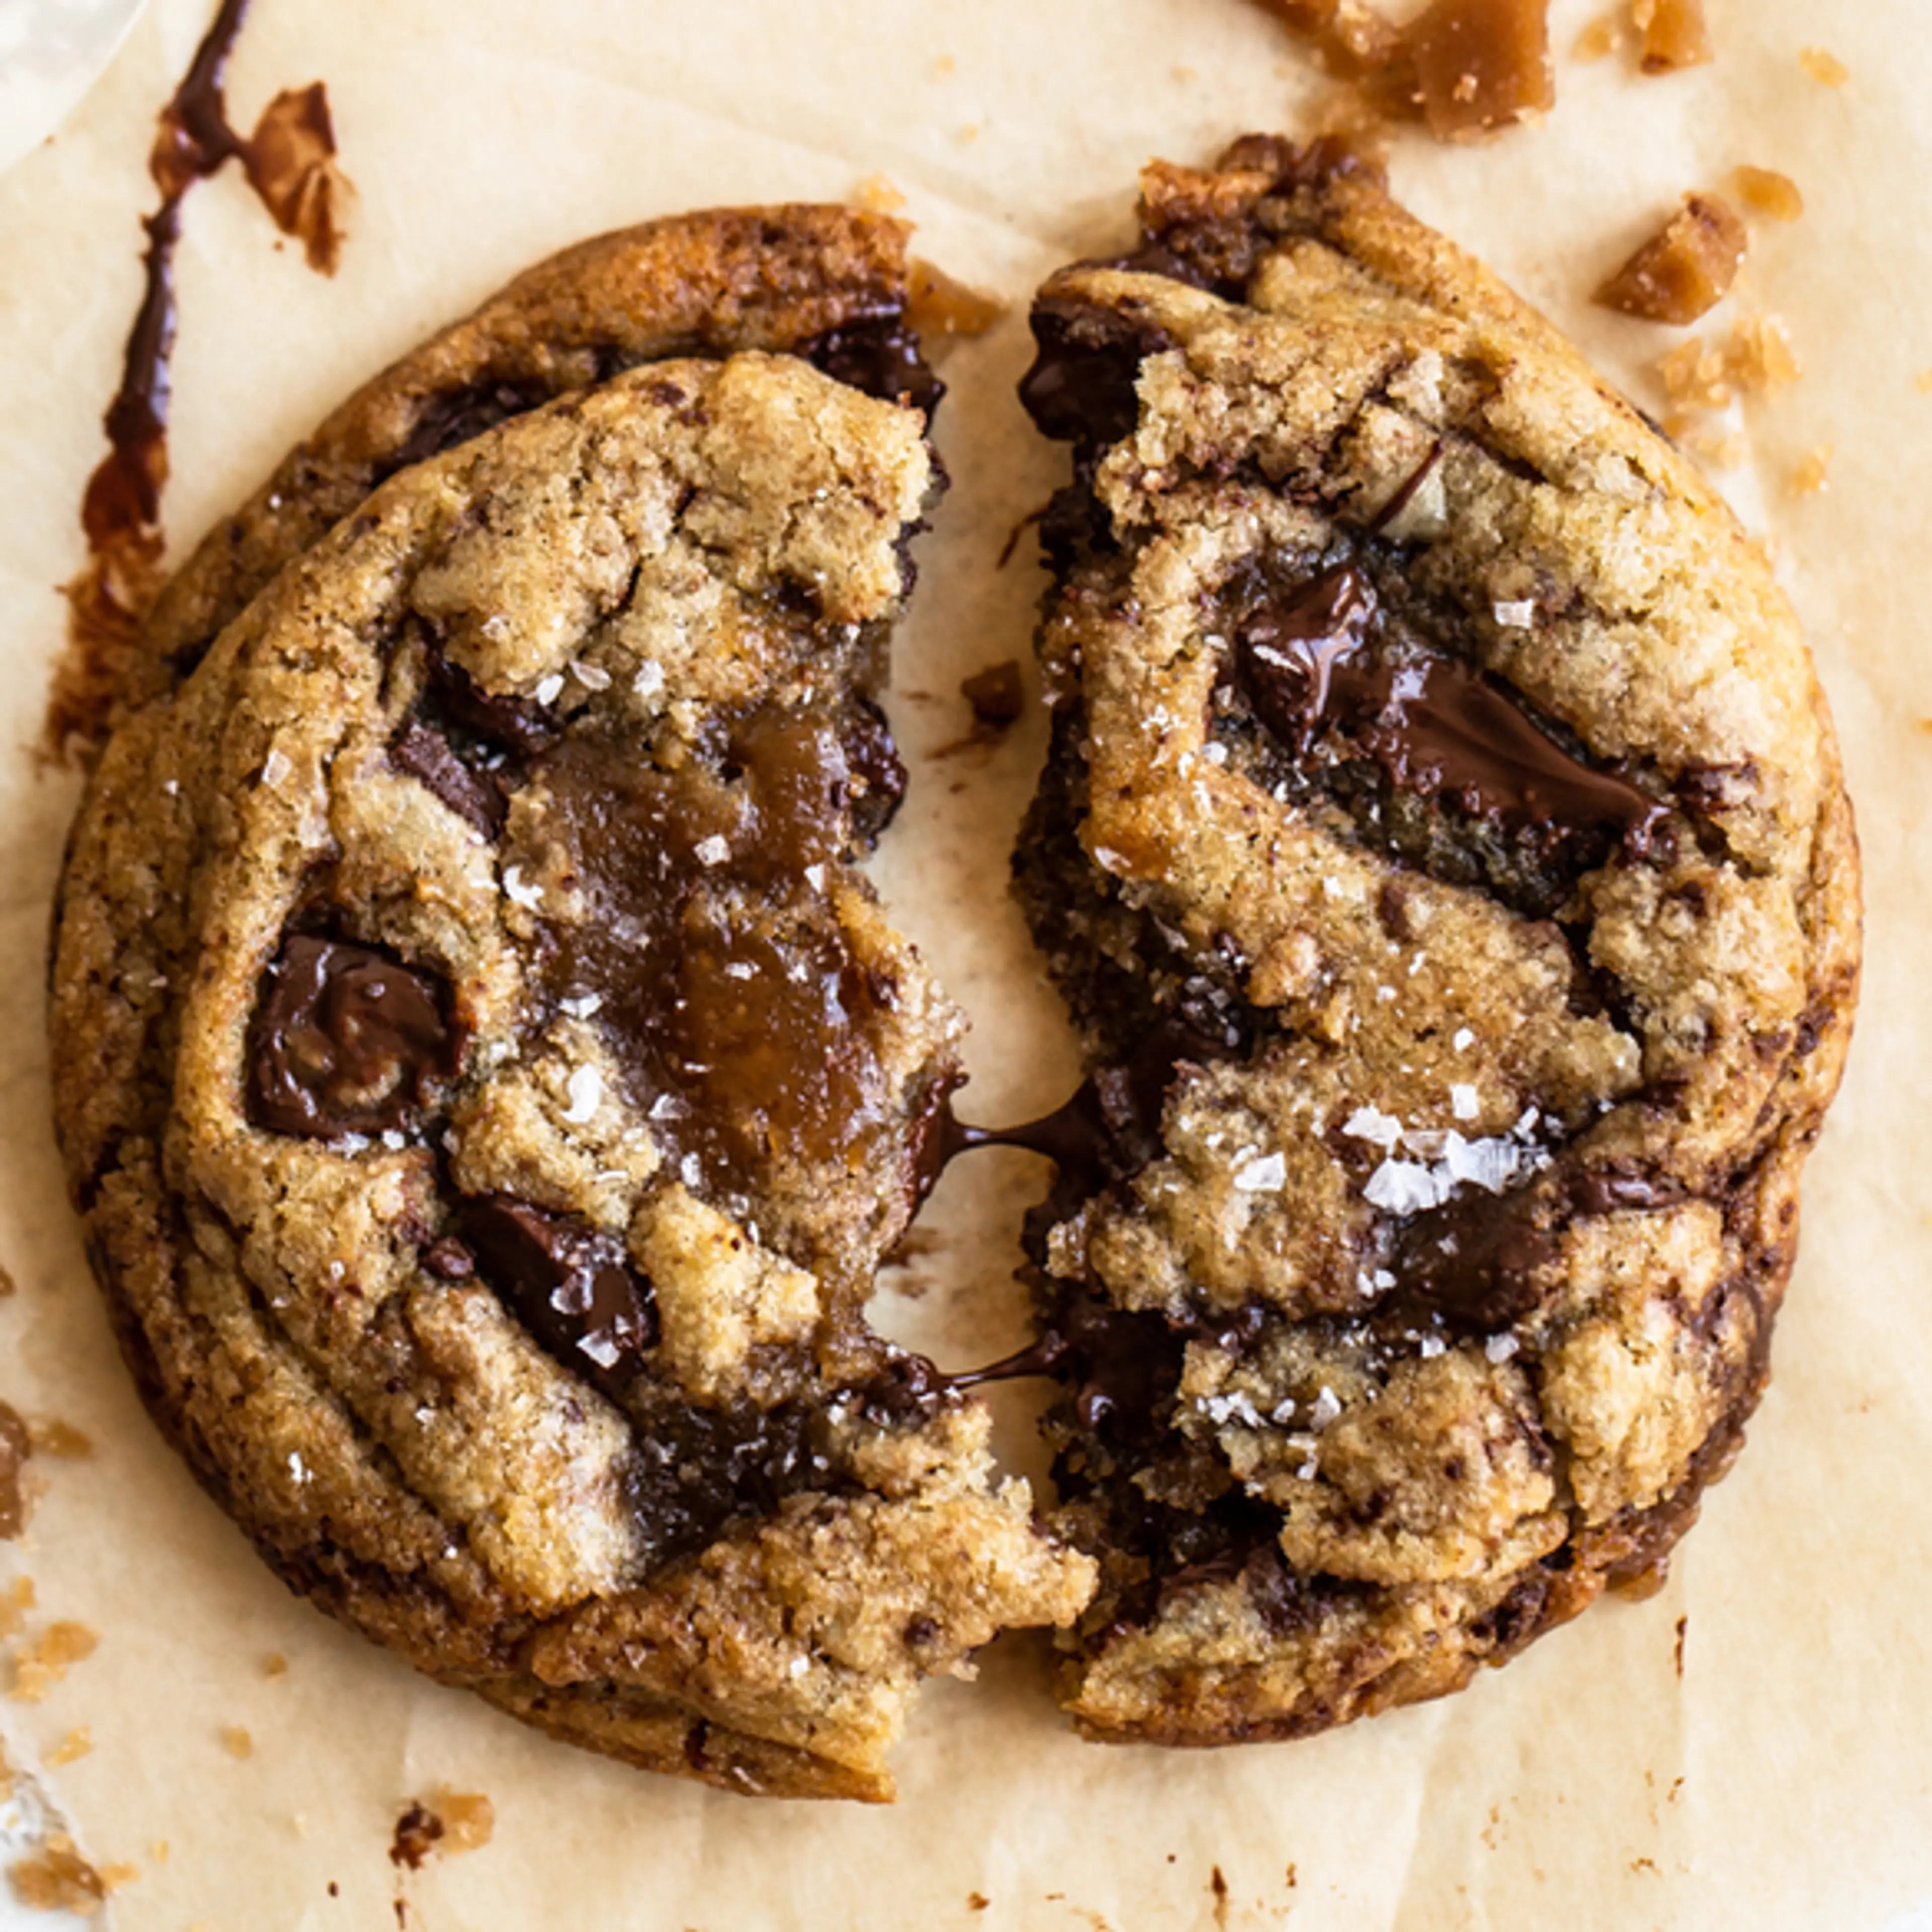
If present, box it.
[248,933,460,1140]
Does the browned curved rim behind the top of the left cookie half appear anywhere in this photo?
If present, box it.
[52,203,943,748]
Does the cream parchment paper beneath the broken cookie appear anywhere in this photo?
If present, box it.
[0,0,1932,1932]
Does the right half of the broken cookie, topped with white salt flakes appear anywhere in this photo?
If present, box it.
[1016,137,1859,1745]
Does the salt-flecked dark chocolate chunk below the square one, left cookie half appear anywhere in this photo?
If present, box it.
[456,1194,657,1401]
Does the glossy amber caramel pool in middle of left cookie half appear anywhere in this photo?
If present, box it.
[533,711,899,1194]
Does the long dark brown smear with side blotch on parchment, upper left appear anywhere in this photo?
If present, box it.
[46,0,350,757]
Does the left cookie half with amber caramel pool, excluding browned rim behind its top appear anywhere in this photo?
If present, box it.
[52,237,1093,1799]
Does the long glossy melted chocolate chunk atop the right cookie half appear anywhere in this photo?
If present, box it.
[1235,564,1665,852]
